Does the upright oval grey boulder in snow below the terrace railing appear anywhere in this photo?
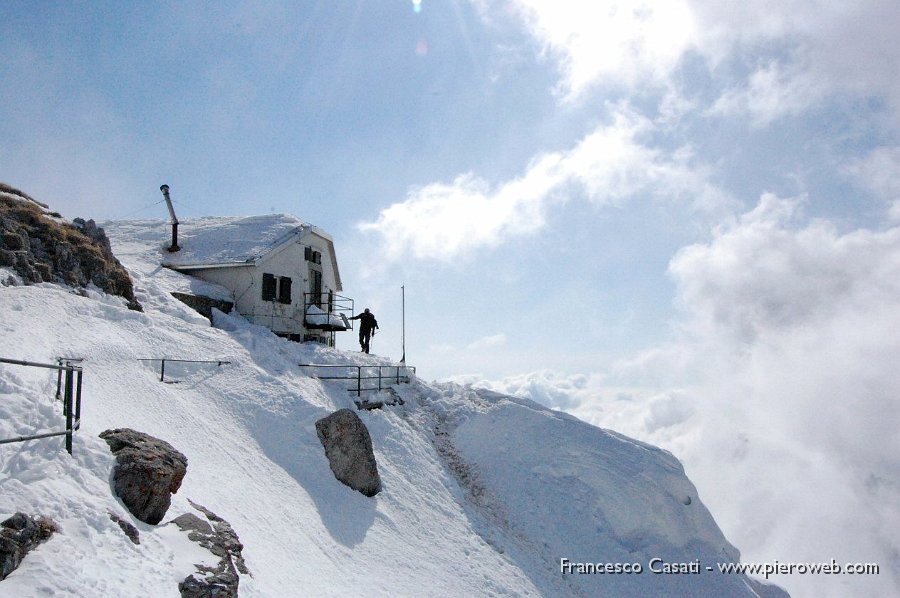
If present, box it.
[316,409,381,496]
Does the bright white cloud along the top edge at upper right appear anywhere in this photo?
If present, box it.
[496,0,900,121]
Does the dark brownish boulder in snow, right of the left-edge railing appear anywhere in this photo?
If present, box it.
[100,428,187,525]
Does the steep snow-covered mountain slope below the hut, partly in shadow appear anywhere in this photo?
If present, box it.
[0,218,783,596]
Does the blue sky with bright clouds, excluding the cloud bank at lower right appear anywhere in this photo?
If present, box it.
[0,0,897,384]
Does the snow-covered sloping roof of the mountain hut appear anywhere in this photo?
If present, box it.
[156,214,312,268]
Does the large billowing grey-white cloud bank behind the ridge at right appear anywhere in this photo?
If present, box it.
[474,195,900,597]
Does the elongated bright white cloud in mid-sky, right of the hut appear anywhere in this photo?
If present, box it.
[359,111,728,262]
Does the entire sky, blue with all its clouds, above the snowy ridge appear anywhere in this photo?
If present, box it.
[0,0,900,596]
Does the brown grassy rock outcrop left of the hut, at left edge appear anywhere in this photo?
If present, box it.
[0,183,142,311]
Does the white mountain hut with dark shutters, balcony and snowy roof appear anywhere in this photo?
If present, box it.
[162,214,353,346]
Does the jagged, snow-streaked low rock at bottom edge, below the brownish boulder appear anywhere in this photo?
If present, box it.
[171,501,250,598]
